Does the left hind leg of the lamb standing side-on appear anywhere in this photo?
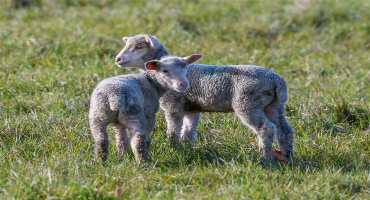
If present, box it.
[235,107,276,158]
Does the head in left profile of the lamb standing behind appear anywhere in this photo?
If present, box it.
[116,35,168,69]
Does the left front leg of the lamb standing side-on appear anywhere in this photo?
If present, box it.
[165,112,184,145]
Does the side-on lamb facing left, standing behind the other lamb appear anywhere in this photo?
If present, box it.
[116,35,294,163]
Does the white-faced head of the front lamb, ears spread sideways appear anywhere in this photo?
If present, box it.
[145,54,202,92]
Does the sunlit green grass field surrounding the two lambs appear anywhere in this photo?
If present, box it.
[0,0,370,199]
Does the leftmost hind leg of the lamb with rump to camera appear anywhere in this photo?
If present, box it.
[90,120,109,161]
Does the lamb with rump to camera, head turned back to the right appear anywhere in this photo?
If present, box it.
[89,54,202,163]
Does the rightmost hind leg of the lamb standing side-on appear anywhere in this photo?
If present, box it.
[265,102,294,163]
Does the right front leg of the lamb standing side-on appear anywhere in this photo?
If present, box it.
[181,113,200,145]
